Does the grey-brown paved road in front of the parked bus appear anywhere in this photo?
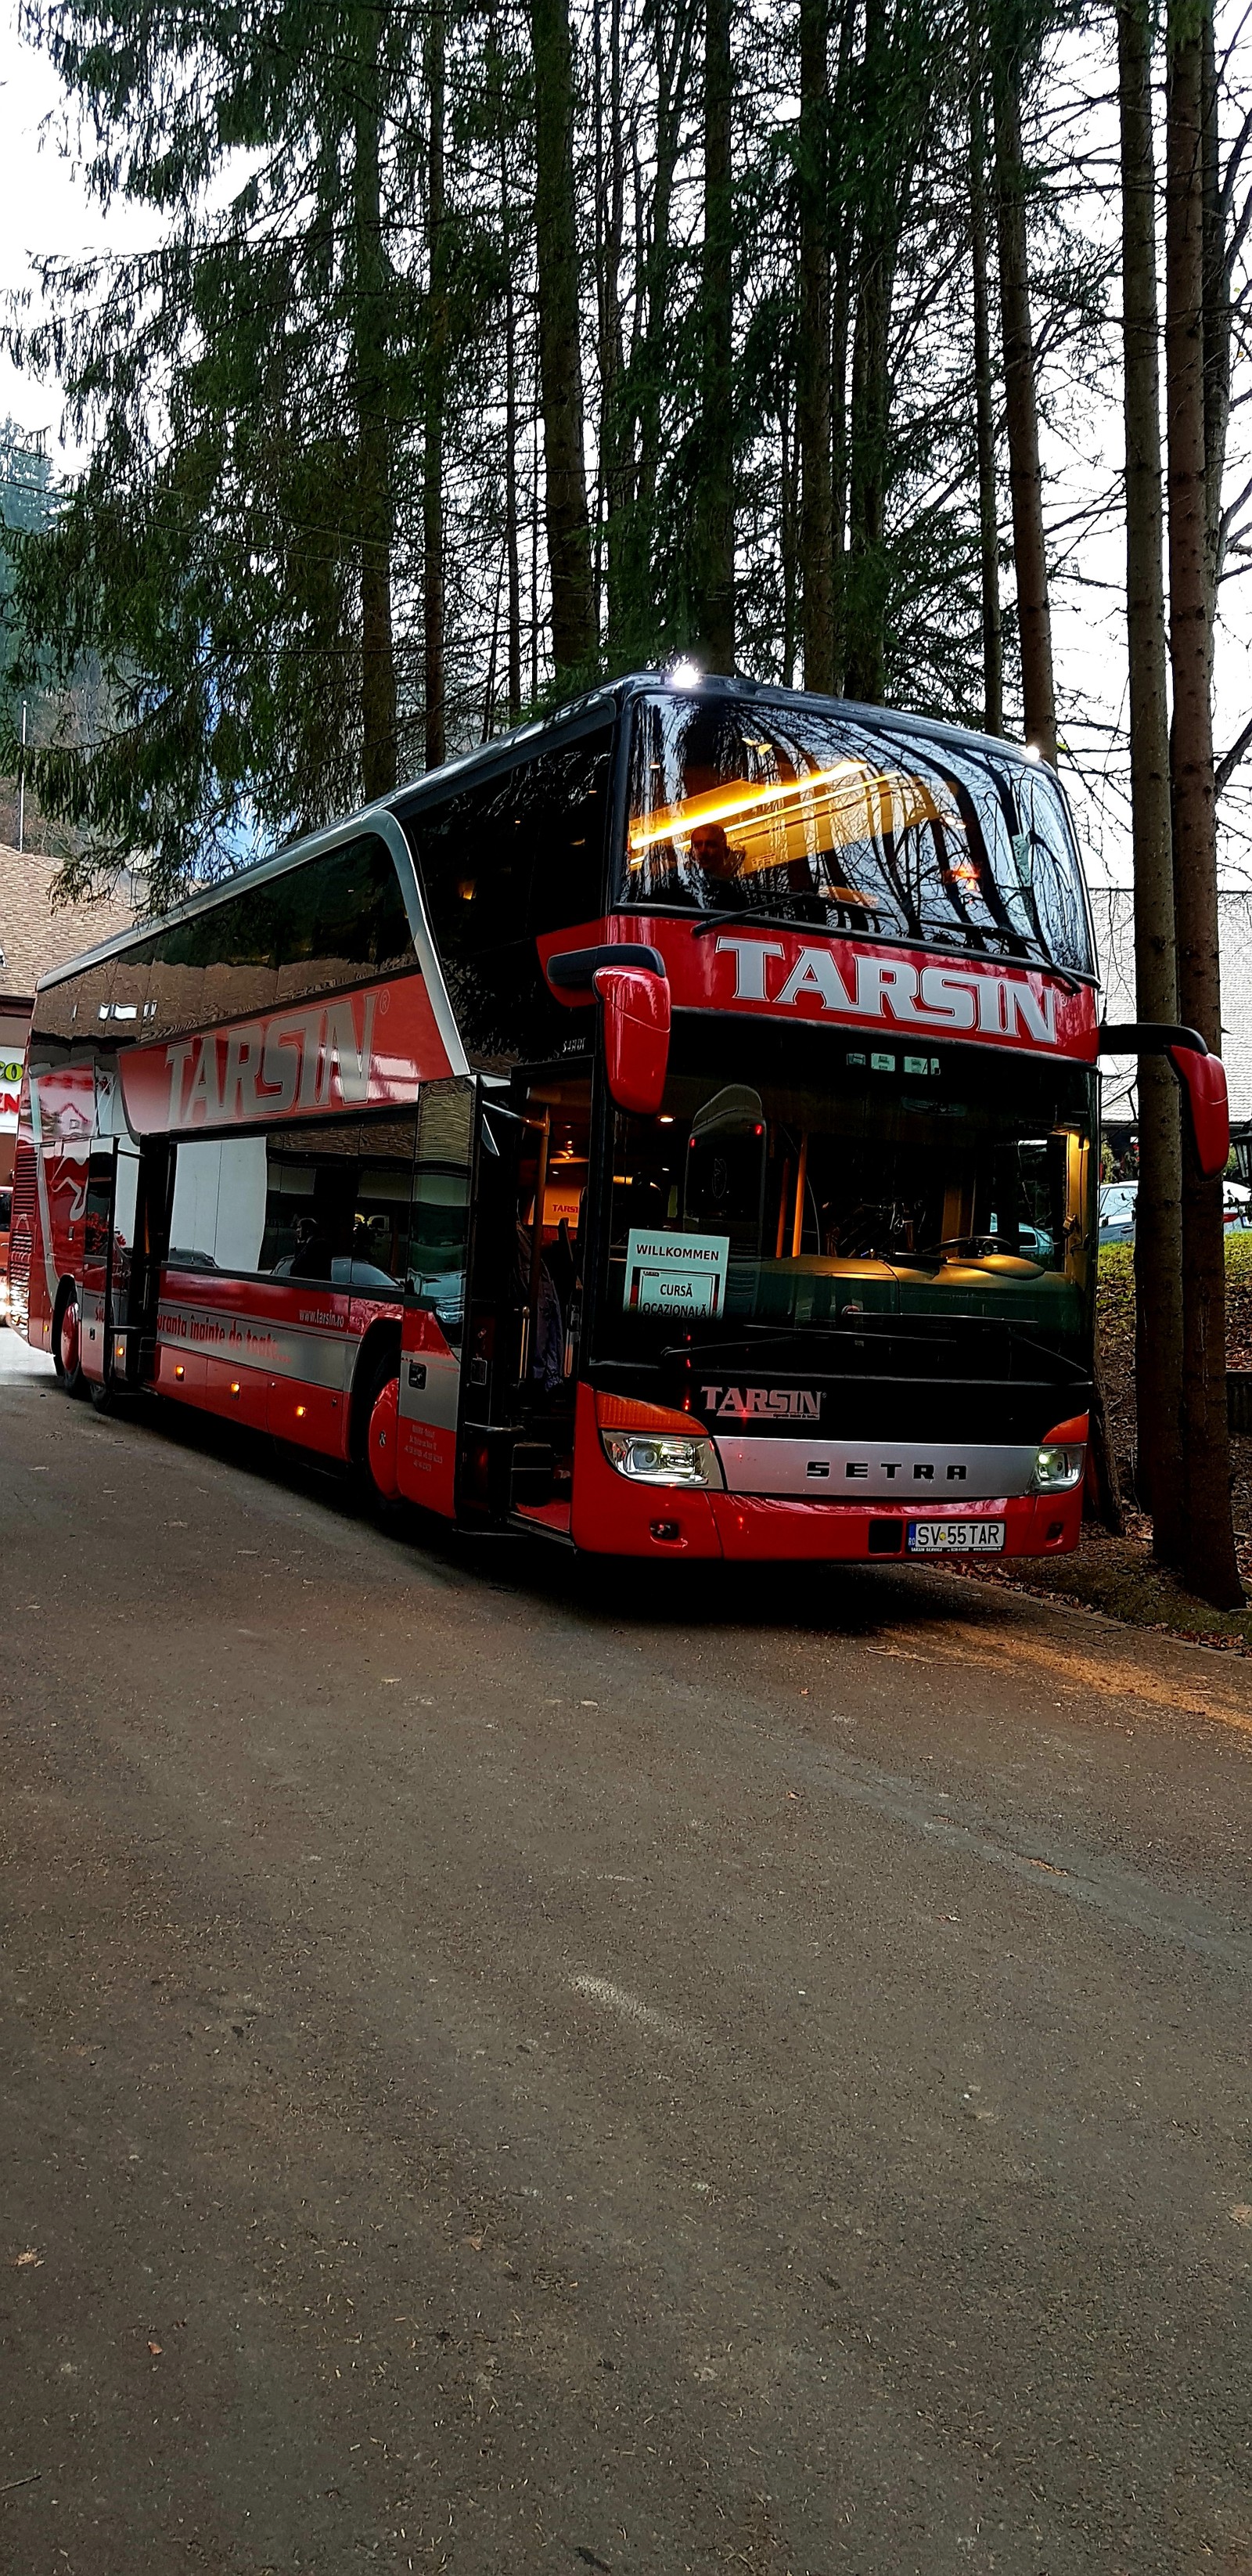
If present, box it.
[0,1335,1252,2576]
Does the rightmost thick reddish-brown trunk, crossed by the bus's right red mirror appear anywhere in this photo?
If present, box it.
[1164,0,1244,1610]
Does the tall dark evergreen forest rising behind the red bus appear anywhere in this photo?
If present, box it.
[0,0,1252,1600]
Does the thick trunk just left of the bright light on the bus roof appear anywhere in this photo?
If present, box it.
[531,0,598,680]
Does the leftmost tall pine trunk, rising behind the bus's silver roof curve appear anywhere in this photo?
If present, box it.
[353,5,397,804]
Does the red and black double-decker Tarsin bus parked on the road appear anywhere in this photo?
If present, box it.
[13,675,1226,1558]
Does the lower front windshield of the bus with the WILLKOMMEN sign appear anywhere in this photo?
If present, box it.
[595,1015,1095,1378]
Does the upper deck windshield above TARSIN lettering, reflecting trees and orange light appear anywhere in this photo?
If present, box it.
[621,693,1092,974]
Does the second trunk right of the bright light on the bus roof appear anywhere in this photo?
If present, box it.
[796,0,835,696]
